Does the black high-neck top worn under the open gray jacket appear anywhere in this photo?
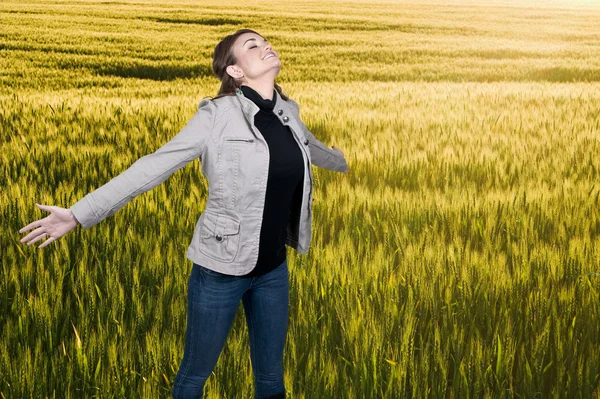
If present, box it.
[238,85,304,277]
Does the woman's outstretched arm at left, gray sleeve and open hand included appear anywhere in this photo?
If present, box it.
[19,100,216,248]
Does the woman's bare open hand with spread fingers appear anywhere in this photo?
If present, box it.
[19,204,79,248]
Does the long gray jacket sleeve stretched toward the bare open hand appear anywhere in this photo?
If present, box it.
[70,99,216,229]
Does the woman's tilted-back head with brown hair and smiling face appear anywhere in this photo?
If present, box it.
[213,29,288,100]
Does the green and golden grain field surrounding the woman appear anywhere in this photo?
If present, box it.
[0,0,600,399]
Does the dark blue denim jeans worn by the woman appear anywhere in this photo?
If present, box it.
[172,260,289,399]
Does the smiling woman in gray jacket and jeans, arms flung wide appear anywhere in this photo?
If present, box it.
[20,29,348,399]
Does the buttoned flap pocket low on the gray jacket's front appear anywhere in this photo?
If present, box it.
[199,210,240,262]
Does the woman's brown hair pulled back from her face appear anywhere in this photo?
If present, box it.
[211,29,288,101]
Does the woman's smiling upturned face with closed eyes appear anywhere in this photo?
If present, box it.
[227,32,281,83]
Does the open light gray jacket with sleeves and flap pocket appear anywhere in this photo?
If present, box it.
[70,90,348,275]
